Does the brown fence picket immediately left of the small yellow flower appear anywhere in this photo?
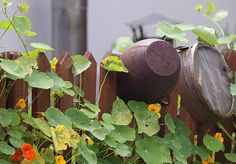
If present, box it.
[32,53,51,116]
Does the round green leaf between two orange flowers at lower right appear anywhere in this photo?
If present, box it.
[203,134,224,152]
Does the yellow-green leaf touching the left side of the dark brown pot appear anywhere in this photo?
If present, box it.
[102,55,128,73]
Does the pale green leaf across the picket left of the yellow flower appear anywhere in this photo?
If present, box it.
[25,70,54,89]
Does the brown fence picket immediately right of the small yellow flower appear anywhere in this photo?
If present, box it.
[55,52,73,112]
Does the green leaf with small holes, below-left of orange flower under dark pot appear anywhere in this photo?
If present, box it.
[134,109,160,136]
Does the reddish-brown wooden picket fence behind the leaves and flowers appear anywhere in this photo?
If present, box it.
[0,52,236,163]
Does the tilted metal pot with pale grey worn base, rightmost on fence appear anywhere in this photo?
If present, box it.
[179,43,235,121]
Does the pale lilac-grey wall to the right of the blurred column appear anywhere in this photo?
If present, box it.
[88,0,236,60]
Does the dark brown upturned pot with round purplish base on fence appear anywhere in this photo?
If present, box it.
[117,39,180,105]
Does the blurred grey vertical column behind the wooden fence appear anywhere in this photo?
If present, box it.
[52,0,87,56]
